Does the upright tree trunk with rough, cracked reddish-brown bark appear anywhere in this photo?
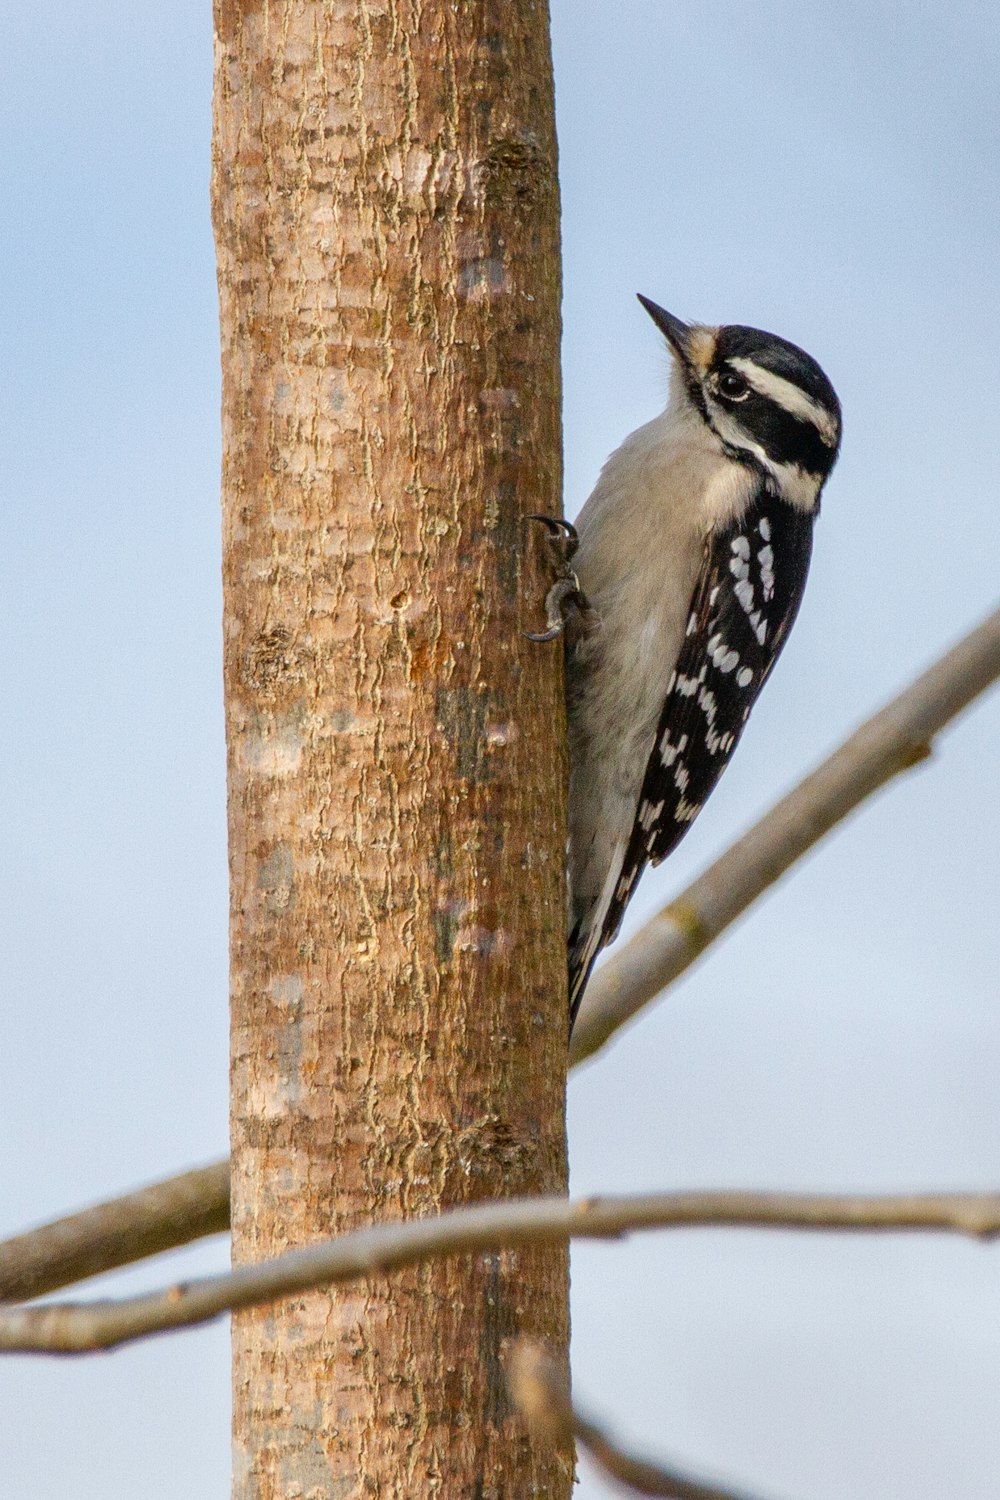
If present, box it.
[213,0,571,1500]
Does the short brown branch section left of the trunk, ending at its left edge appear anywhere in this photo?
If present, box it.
[0,1161,229,1302]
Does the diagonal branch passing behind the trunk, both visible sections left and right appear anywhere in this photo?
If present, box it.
[0,611,1000,1299]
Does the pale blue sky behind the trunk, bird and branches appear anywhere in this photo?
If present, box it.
[0,0,1000,1500]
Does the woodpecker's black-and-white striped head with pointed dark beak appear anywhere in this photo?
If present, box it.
[639,296,841,510]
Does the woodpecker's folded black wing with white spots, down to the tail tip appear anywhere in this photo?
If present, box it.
[570,492,814,1014]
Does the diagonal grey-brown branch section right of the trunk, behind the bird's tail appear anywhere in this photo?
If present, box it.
[570,609,1000,1064]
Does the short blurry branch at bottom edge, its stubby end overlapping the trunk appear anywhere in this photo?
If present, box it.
[507,1338,779,1500]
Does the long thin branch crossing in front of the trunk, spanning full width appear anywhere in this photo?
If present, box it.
[0,1193,1000,1355]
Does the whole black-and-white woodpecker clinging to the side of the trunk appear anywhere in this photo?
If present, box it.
[564,297,841,1017]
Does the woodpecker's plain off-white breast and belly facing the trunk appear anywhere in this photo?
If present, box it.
[568,389,756,923]
